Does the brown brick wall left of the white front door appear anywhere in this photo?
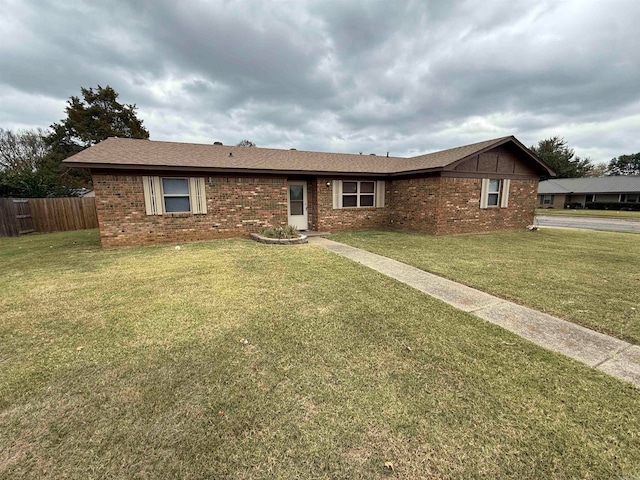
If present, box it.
[93,172,287,247]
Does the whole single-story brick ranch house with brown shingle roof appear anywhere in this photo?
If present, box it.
[65,137,553,247]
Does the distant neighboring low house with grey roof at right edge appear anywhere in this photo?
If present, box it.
[538,175,640,208]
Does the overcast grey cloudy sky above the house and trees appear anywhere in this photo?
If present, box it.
[0,0,640,162]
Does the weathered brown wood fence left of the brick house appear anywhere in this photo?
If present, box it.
[0,197,98,237]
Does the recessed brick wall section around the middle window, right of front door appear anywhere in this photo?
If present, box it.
[308,177,390,232]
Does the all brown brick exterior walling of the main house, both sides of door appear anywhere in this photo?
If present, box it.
[93,172,538,247]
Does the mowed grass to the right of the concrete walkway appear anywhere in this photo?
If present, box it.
[331,229,640,344]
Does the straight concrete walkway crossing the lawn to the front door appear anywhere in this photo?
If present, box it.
[309,237,640,387]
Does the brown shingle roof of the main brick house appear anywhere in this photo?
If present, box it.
[65,137,556,174]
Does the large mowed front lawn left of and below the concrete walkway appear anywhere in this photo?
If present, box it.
[0,231,640,479]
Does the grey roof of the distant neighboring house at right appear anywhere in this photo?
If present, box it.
[538,175,640,195]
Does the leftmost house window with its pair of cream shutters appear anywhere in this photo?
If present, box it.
[142,176,207,215]
